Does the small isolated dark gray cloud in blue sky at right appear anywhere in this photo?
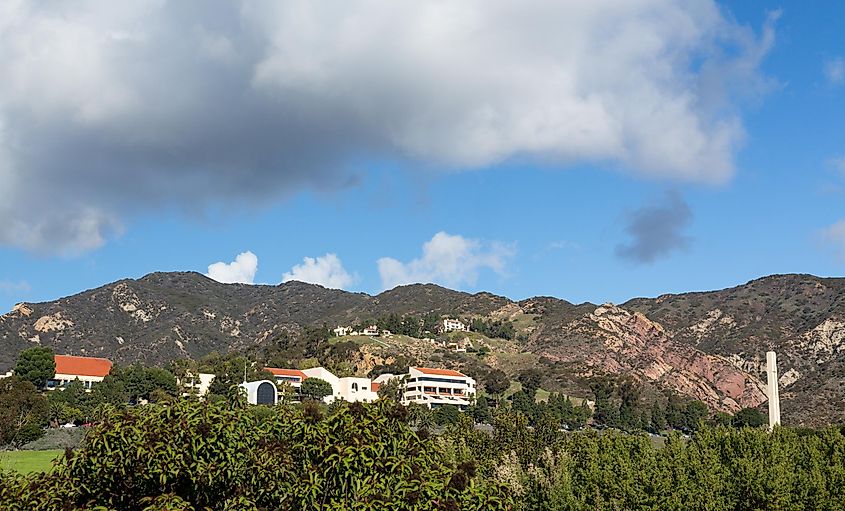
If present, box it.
[616,192,692,263]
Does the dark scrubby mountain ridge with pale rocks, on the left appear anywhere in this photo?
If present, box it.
[0,272,507,371]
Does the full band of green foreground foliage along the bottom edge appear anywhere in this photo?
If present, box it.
[0,393,845,511]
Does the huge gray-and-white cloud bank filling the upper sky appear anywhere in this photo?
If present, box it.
[0,0,776,253]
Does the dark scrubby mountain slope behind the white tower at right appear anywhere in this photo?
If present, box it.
[622,275,845,423]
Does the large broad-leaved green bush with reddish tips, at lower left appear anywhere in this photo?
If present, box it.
[0,401,509,511]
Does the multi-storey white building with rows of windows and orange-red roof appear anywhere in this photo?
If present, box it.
[375,367,476,410]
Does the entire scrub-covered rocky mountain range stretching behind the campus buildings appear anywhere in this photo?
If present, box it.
[0,273,845,424]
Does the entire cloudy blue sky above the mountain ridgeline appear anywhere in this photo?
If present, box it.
[0,0,845,310]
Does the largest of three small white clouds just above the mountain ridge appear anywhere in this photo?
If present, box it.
[378,231,514,289]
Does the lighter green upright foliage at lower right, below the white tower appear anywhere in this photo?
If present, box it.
[443,412,845,511]
